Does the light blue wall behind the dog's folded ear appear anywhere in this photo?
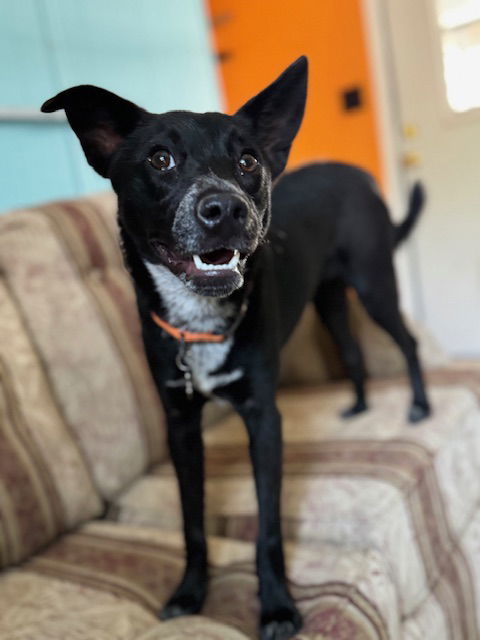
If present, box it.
[0,0,221,211]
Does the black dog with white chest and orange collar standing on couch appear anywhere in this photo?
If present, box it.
[42,57,428,640]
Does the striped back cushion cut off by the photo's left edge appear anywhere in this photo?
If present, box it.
[0,278,103,567]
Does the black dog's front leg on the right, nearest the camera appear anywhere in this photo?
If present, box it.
[238,398,302,640]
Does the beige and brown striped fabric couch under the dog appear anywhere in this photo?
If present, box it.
[0,193,480,640]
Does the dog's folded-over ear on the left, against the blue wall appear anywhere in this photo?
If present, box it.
[41,84,147,178]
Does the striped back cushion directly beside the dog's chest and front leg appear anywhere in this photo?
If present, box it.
[0,194,165,498]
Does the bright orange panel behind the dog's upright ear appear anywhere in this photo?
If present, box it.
[207,0,381,185]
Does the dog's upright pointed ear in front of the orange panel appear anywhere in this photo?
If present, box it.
[235,56,308,178]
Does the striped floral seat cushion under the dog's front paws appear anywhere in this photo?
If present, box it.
[0,522,398,640]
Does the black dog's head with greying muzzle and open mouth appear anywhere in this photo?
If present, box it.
[42,57,307,296]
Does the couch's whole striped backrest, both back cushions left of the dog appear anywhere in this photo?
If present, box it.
[0,194,165,566]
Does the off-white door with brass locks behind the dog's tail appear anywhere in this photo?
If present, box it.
[387,0,480,356]
